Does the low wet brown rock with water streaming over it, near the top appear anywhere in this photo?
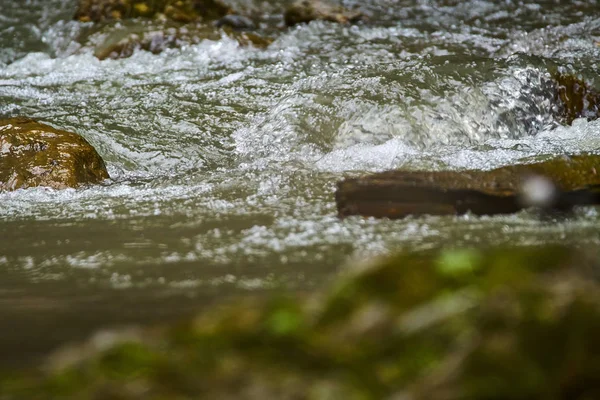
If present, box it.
[90,23,273,60]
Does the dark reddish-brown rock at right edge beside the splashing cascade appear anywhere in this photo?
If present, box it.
[555,75,600,125]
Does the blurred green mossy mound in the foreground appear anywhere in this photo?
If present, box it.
[0,246,600,400]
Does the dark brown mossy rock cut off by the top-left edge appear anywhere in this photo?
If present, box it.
[75,0,231,22]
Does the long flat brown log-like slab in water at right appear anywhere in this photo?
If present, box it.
[335,155,600,219]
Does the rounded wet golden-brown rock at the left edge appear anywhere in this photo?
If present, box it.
[0,118,109,191]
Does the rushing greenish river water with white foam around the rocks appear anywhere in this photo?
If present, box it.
[0,0,600,367]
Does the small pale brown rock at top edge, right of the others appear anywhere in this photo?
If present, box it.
[283,0,364,26]
